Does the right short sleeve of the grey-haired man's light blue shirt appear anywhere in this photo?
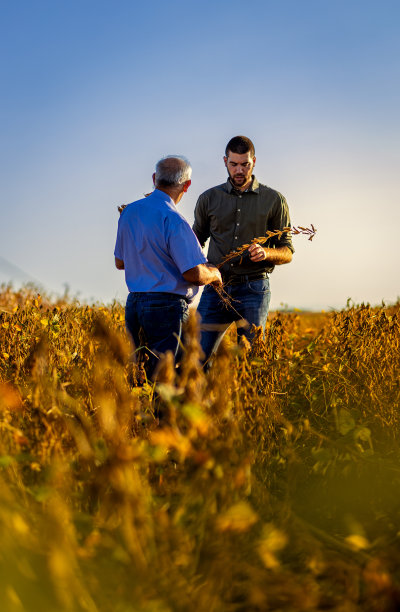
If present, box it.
[168,218,207,274]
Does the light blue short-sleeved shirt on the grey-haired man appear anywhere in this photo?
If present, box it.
[114,189,207,299]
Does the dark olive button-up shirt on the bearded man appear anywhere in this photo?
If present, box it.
[193,176,294,274]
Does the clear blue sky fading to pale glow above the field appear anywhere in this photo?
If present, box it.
[0,0,400,309]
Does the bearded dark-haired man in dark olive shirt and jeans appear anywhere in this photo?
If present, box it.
[193,136,293,359]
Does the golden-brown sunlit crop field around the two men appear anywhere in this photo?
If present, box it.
[0,287,400,612]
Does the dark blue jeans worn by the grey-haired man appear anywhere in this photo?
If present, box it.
[125,292,189,378]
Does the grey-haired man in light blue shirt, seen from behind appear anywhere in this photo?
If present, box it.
[114,156,222,378]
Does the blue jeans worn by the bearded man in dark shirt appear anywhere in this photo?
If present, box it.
[197,278,271,361]
